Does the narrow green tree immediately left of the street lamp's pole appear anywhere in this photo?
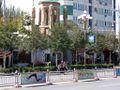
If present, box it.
[67,21,84,63]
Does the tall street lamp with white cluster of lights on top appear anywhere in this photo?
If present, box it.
[78,10,93,64]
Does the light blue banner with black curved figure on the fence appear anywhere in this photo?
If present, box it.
[21,72,46,84]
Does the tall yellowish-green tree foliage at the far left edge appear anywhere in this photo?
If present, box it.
[0,7,24,50]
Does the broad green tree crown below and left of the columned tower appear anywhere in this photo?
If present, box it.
[19,29,48,53]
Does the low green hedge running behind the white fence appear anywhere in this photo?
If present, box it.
[0,64,113,73]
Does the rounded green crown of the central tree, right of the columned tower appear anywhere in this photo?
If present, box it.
[49,24,70,51]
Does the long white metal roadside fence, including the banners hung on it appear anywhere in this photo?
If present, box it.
[0,69,116,87]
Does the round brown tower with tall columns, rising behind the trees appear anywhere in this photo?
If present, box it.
[38,2,60,34]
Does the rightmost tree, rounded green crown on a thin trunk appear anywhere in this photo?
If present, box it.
[97,31,118,63]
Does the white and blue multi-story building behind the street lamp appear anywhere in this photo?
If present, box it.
[38,0,116,31]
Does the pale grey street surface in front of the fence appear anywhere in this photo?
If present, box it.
[9,78,120,90]
